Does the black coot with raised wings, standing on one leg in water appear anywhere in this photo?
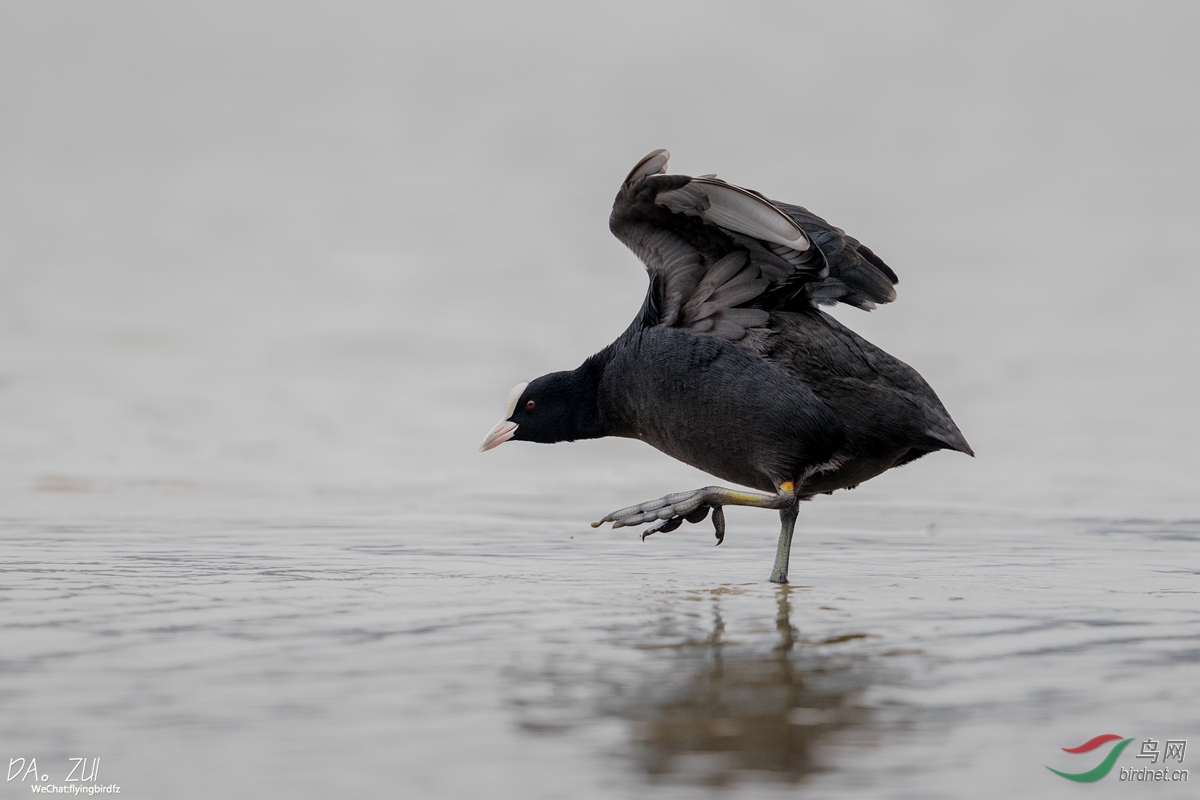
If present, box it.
[480,150,974,584]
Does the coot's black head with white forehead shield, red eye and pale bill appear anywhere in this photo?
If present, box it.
[479,367,602,452]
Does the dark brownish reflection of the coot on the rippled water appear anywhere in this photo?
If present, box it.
[514,587,875,787]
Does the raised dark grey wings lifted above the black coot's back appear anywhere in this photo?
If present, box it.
[608,150,896,341]
